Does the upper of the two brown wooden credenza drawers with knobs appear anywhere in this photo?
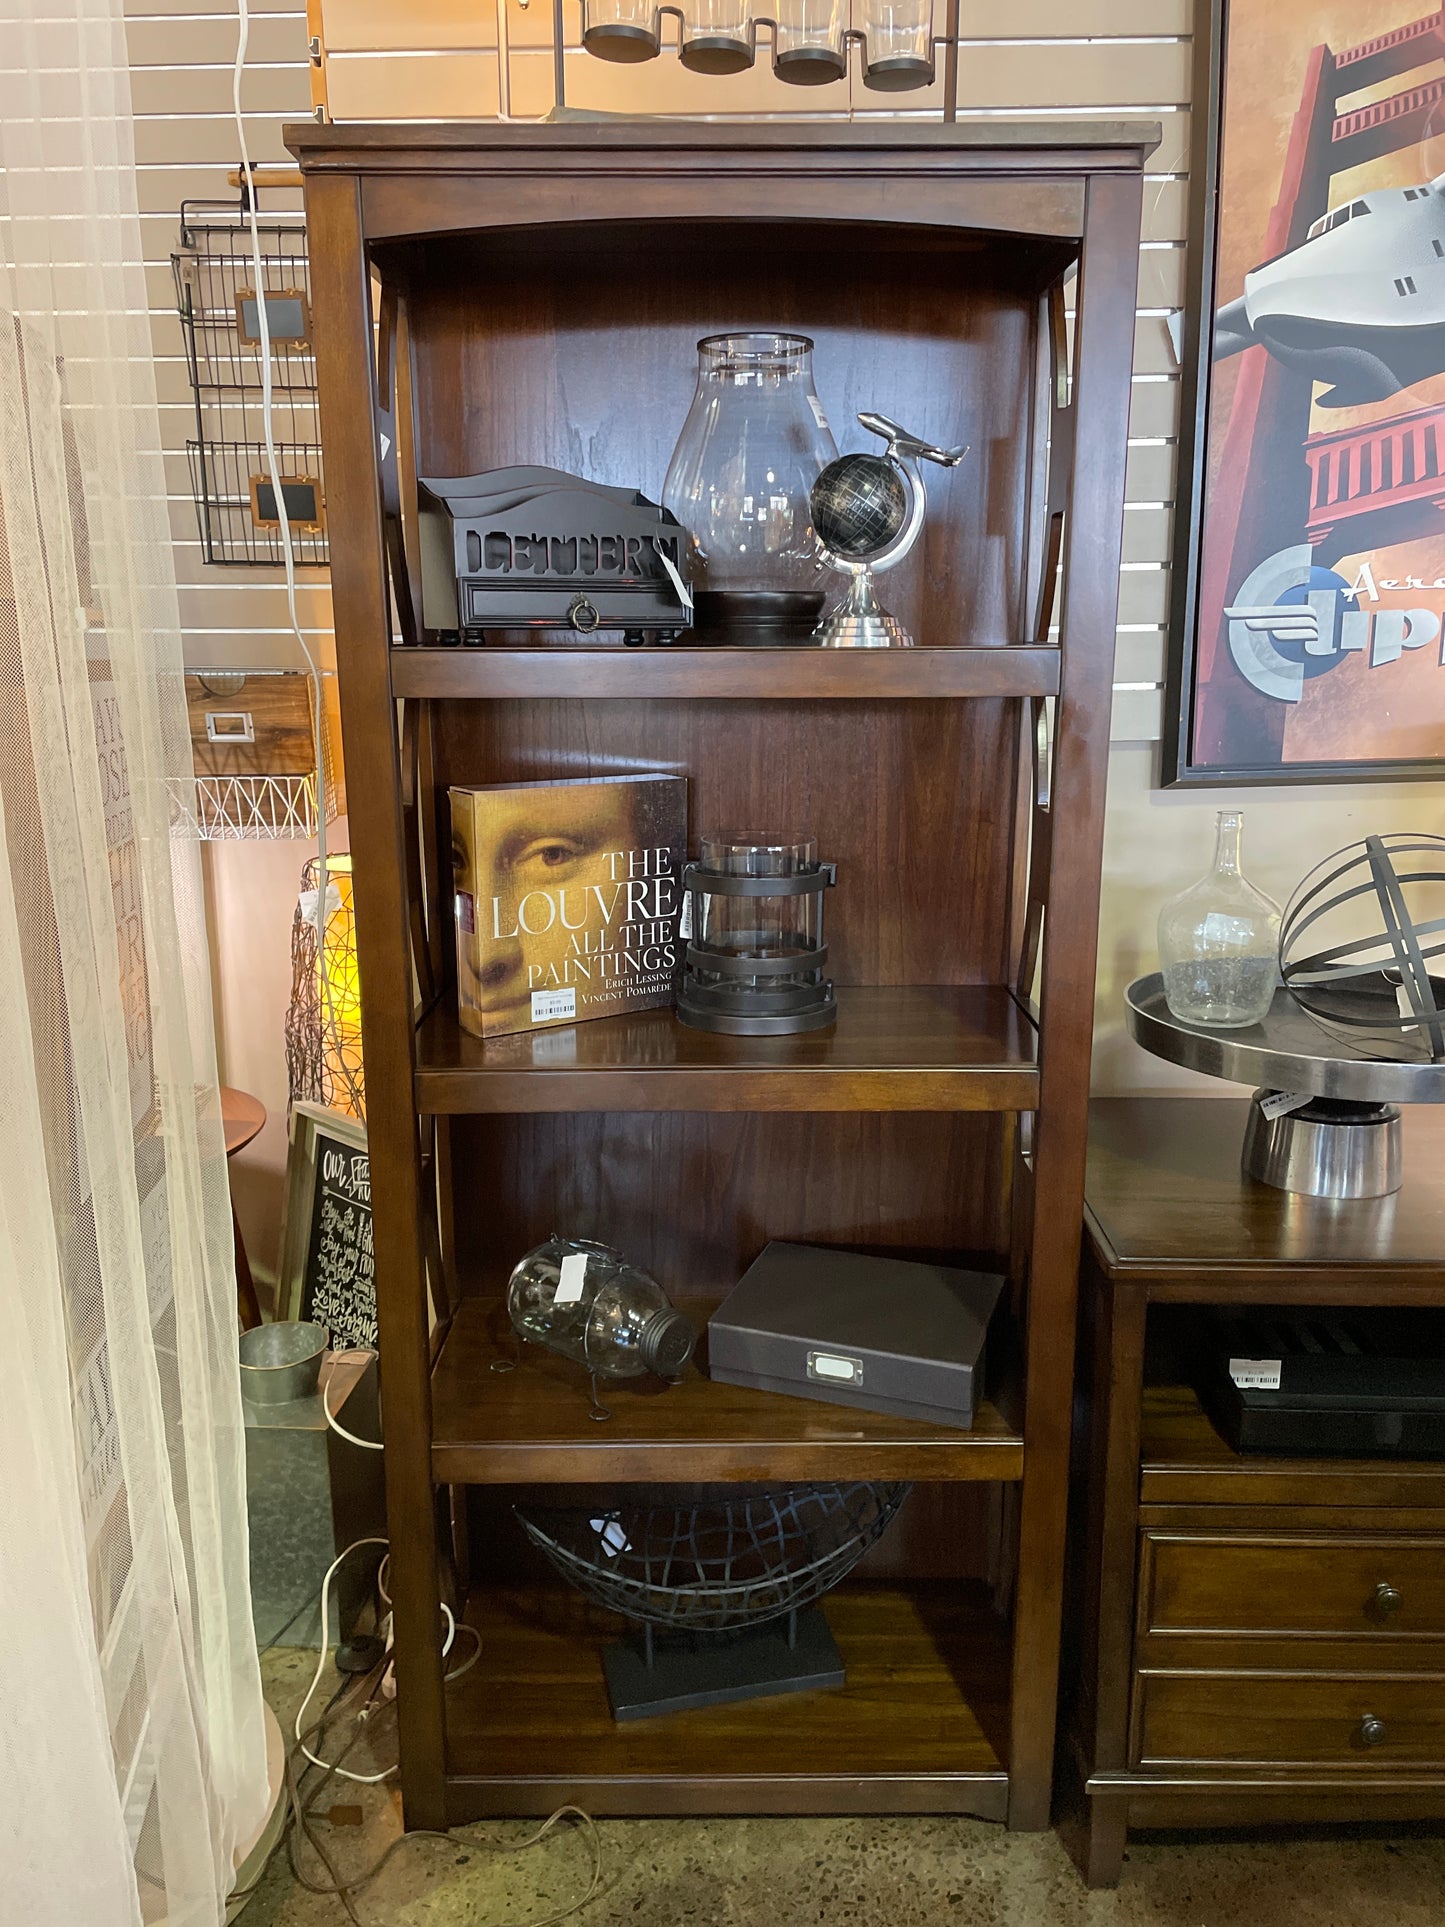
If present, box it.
[1139,1530,1445,1638]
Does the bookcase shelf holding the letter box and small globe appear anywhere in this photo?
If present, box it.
[391,644,1060,700]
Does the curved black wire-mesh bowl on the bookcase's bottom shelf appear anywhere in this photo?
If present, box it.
[516,1482,911,1632]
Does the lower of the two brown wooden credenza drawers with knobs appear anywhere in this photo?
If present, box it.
[1133,1673,1445,1773]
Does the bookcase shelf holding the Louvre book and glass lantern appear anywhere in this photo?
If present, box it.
[416,985,1038,1116]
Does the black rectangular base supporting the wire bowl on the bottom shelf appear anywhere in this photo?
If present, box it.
[603,1605,844,1721]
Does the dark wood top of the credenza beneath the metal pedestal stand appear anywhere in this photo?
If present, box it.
[1085,1096,1445,1299]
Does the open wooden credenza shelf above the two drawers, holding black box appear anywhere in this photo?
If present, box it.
[1139,1386,1445,1509]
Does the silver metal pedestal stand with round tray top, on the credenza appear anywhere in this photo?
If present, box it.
[1125,971,1445,1199]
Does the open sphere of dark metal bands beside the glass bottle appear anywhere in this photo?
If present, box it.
[1279,831,1445,1064]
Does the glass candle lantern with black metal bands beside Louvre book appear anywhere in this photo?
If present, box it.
[678,831,838,1037]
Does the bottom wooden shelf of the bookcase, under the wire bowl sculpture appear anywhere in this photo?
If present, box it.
[447,1582,1008,1825]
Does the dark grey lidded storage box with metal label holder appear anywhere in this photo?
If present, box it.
[707,1239,1004,1430]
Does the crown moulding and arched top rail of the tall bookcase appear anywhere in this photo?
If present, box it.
[285,119,1160,256]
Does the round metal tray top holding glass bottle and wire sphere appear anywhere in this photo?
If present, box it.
[1125,971,1445,1104]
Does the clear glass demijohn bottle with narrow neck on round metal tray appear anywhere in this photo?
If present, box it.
[1160,809,1279,1031]
